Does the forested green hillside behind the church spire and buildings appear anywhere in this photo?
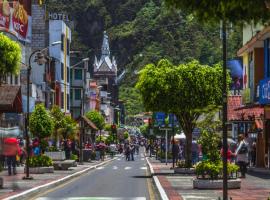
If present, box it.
[47,0,242,115]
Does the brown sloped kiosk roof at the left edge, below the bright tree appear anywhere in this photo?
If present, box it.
[0,85,22,113]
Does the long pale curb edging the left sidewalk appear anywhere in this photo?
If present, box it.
[4,157,117,200]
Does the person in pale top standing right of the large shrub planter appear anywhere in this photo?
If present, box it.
[235,134,248,178]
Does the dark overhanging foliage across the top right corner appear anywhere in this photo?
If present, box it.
[165,0,270,23]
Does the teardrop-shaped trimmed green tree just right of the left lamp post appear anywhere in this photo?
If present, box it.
[29,104,54,139]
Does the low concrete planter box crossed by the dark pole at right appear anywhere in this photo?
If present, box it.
[193,179,241,189]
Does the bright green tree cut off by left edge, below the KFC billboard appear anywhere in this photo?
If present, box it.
[0,33,21,85]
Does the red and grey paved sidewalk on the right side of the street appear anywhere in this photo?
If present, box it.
[147,157,270,200]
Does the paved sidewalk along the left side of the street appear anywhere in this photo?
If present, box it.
[0,158,115,199]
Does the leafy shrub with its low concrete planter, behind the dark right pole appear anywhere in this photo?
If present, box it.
[193,130,241,189]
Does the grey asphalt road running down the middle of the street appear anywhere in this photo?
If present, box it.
[37,153,156,200]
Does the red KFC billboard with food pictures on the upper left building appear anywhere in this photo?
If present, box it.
[0,0,32,42]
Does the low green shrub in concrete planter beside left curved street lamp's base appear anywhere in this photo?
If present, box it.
[29,155,53,174]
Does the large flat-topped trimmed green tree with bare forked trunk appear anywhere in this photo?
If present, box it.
[136,60,230,166]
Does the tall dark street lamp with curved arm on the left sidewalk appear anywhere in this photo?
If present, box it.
[23,41,61,180]
